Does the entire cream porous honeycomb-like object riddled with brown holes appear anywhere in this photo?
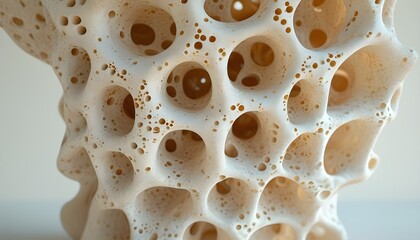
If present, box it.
[0,0,416,240]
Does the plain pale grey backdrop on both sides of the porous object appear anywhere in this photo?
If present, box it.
[0,0,420,239]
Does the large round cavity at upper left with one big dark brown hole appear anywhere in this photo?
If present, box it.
[109,3,177,56]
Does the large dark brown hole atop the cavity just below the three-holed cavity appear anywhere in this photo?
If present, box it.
[232,113,259,139]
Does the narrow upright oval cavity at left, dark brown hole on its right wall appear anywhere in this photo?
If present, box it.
[100,86,135,135]
